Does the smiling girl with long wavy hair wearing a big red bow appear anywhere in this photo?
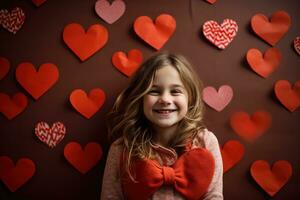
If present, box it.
[101,53,223,200]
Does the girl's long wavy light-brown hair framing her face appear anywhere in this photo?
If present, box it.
[107,53,205,178]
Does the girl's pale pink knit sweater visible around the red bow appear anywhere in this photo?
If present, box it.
[101,129,223,200]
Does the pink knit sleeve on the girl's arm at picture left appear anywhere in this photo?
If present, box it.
[101,142,124,200]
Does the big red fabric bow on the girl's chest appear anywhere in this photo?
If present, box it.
[122,148,215,200]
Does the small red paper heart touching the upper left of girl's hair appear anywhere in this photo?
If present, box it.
[112,49,143,77]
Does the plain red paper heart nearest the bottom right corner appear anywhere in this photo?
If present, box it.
[250,160,293,197]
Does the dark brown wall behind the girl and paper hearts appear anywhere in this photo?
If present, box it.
[0,0,300,200]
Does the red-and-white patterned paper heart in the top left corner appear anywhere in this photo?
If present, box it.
[0,7,25,34]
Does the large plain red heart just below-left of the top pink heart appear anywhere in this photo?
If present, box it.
[63,23,108,61]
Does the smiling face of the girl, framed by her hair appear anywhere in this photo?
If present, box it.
[143,66,188,130]
